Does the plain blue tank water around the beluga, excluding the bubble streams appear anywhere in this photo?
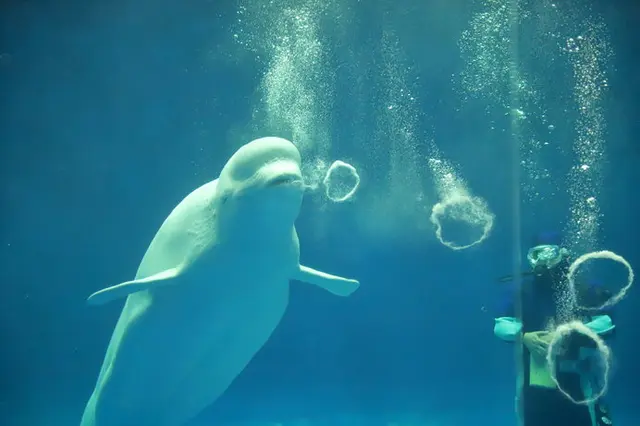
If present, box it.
[0,0,640,426]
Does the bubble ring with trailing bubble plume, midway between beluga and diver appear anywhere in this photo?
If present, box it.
[428,158,495,250]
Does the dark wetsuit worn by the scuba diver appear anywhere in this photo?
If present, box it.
[496,265,611,426]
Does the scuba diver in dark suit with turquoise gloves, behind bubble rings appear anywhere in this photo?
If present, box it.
[494,232,615,426]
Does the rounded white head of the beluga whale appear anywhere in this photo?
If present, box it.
[216,137,305,235]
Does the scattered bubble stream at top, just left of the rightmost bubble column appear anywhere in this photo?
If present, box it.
[459,0,555,207]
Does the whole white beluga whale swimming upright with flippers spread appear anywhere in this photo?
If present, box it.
[81,137,360,426]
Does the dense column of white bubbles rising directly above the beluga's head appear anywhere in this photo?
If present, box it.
[232,0,334,156]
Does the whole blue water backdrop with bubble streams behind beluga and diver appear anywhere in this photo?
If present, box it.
[0,0,640,426]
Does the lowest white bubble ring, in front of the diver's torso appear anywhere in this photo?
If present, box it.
[547,321,611,405]
